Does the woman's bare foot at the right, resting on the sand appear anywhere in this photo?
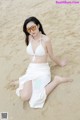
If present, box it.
[54,76,73,84]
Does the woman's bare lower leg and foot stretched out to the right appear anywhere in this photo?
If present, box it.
[45,76,72,95]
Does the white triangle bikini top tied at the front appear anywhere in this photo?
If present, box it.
[26,34,45,61]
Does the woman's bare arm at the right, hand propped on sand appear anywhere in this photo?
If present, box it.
[46,38,66,67]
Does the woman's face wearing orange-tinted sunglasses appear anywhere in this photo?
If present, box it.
[26,22,39,37]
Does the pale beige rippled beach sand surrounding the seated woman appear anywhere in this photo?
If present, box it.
[0,0,80,120]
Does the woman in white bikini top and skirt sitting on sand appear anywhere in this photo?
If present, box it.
[9,17,71,108]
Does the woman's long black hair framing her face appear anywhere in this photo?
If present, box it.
[23,16,46,45]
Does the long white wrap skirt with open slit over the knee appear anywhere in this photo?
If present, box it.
[16,63,51,108]
